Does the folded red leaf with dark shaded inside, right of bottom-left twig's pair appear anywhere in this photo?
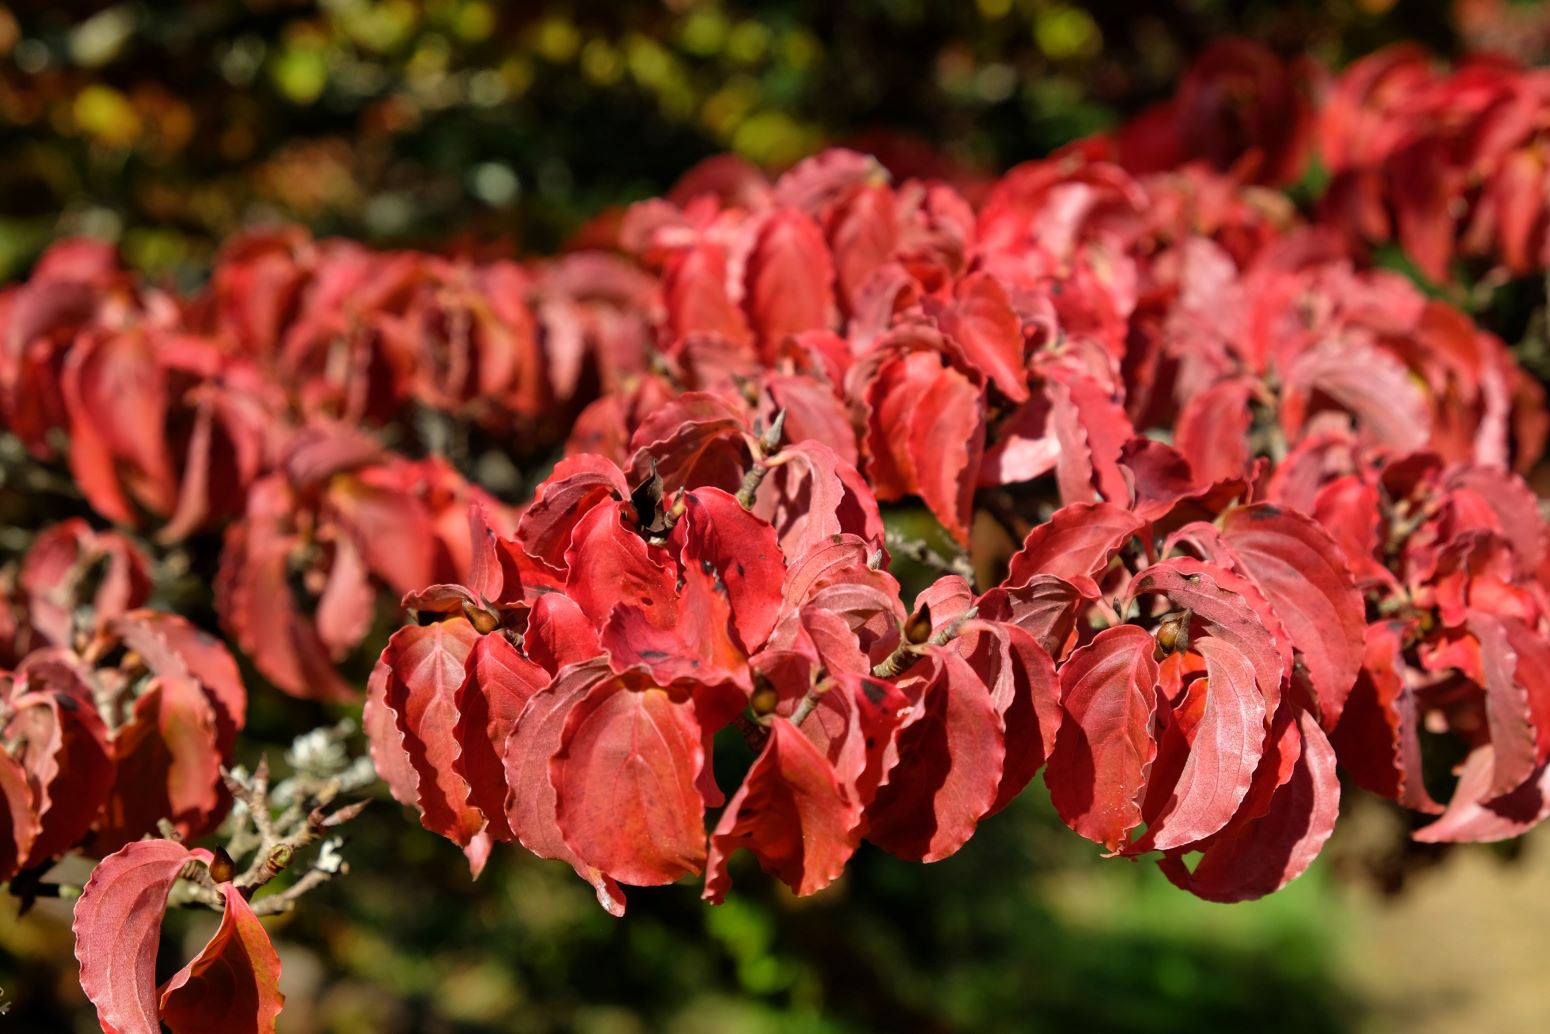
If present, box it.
[161,884,285,1034]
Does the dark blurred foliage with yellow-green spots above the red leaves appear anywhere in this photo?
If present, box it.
[0,0,1550,277]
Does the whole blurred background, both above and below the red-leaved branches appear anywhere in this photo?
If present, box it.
[0,0,1550,1034]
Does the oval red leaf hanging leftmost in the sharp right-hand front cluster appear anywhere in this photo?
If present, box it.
[1045,625,1158,851]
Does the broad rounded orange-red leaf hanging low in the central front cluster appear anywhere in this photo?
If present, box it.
[549,677,705,887]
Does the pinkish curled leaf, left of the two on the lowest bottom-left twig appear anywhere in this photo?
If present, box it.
[71,840,209,1034]
